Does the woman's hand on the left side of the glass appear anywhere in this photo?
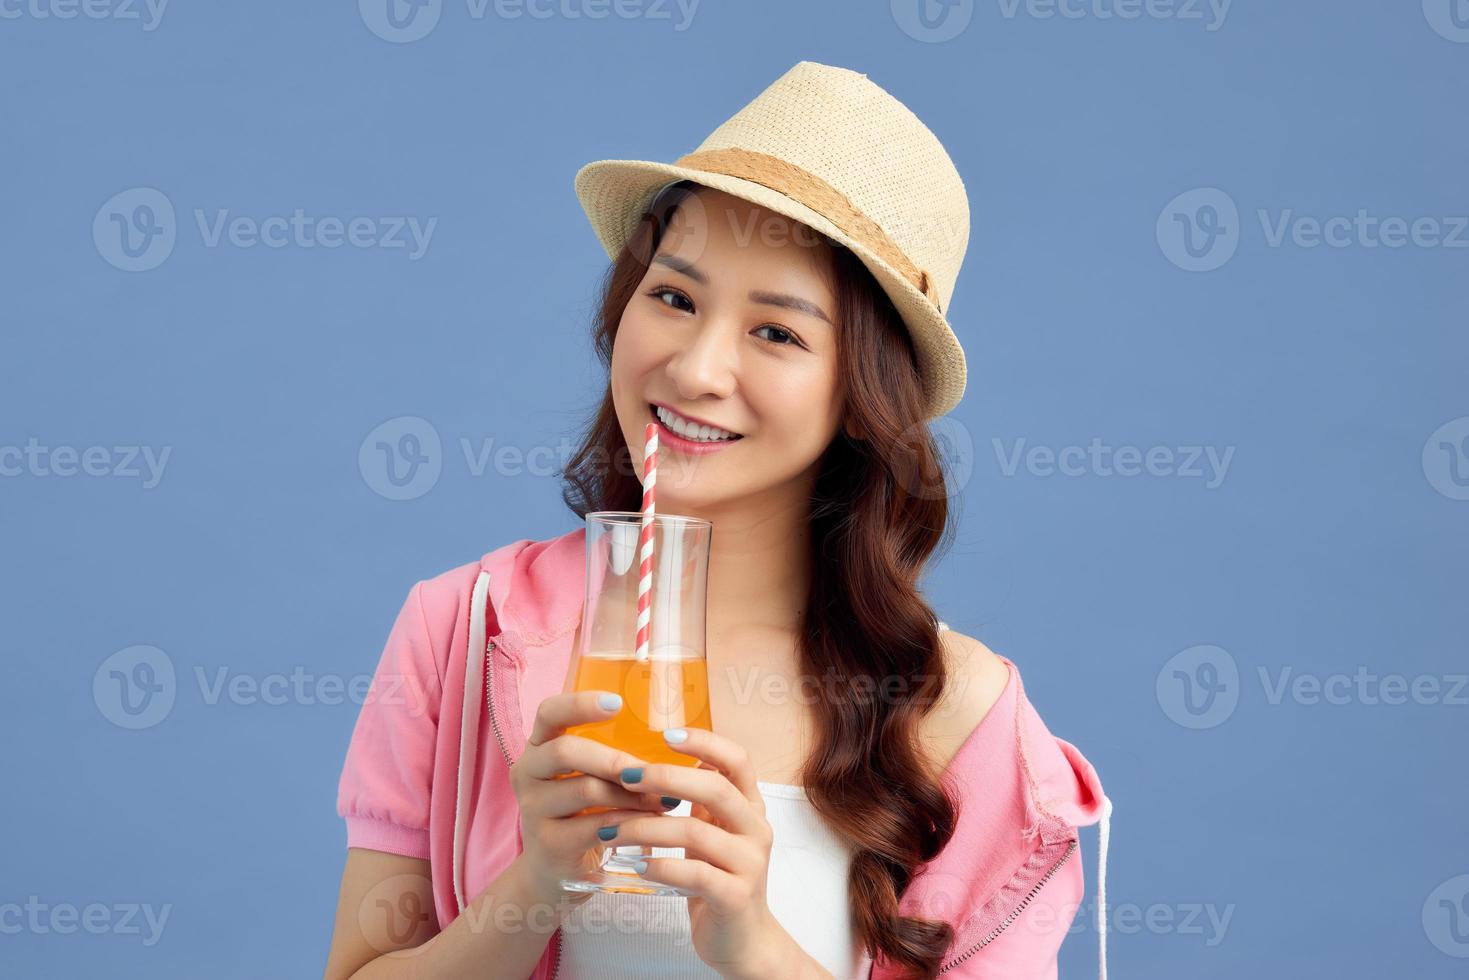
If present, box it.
[510,691,664,905]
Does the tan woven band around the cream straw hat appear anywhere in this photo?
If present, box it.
[673,147,943,313]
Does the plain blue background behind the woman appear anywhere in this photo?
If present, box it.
[0,0,1469,979]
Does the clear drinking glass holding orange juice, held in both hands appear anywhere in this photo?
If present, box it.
[561,510,714,896]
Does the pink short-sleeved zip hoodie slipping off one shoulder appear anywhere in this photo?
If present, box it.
[336,527,1111,980]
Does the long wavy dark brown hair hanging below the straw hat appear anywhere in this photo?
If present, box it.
[561,181,958,979]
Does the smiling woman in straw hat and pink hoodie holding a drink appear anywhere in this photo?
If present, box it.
[326,62,1108,979]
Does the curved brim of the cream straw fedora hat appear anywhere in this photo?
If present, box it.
[576,160,968,419]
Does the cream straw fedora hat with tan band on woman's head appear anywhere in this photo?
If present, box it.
[576,62,970,419]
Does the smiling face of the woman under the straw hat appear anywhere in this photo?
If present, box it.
[611,188,842,516]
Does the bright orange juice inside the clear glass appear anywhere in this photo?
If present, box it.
[558,649,712,814]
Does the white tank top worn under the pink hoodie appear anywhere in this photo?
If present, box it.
[557,782,873,980]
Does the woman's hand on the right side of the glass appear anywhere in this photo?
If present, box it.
[613,729,789,977]
